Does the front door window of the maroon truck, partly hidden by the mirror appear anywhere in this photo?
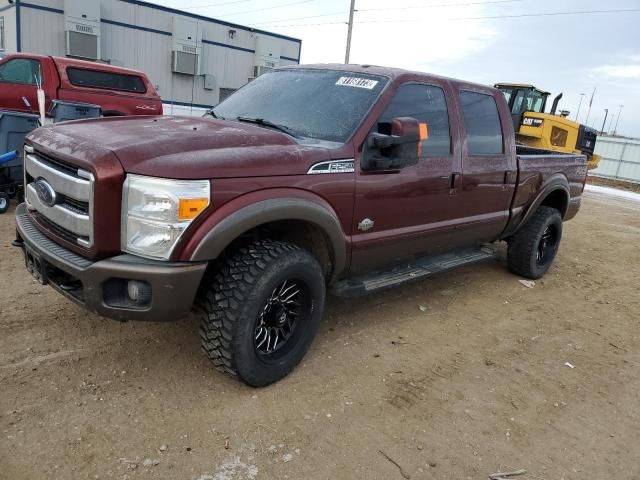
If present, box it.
[378,83,451,158]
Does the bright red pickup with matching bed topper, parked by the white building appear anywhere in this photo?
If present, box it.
[0,53,162,116]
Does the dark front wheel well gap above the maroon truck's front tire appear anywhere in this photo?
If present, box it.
[223,220,334,279]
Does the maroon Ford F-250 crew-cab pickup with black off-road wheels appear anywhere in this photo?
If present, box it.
[15,65,587,386]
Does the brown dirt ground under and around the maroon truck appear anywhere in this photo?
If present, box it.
[0,194,640,480]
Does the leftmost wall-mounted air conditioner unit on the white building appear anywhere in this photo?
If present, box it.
[64,0,100,60]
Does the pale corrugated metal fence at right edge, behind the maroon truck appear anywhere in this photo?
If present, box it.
[590,137,640,182]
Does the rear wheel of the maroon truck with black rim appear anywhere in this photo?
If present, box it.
[507,207,562,280]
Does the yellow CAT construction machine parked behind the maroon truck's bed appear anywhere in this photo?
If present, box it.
[495,83,600,170]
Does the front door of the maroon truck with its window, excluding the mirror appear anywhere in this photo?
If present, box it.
[351,83,460,272]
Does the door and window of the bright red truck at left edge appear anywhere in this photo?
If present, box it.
[0,57,42,113]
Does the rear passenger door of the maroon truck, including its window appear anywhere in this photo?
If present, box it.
[453,87,517,245]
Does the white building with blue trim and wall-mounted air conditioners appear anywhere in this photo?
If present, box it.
[0,0,301,110]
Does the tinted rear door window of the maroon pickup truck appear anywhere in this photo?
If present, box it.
[460,91,503,155]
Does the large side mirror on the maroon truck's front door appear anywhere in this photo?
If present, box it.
[362,117,421,170]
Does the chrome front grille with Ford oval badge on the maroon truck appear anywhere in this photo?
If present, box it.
[25,147,94,248]
